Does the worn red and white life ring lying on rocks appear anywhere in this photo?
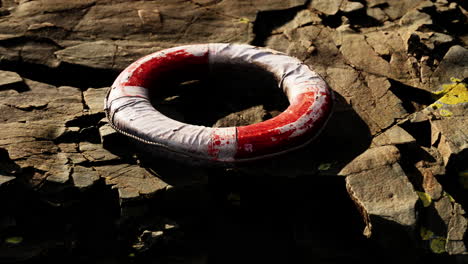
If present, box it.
[104,43,333,163]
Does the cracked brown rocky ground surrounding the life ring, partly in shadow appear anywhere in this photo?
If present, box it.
[0,0,468,263]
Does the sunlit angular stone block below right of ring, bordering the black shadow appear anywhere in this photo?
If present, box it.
[341,146,418,236]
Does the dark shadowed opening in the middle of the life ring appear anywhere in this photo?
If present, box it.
[149,64,289,127]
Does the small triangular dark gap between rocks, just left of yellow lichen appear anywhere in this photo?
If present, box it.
[389,79,437,113]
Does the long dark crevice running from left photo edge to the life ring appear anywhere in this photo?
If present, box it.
[0,61,119,90]
